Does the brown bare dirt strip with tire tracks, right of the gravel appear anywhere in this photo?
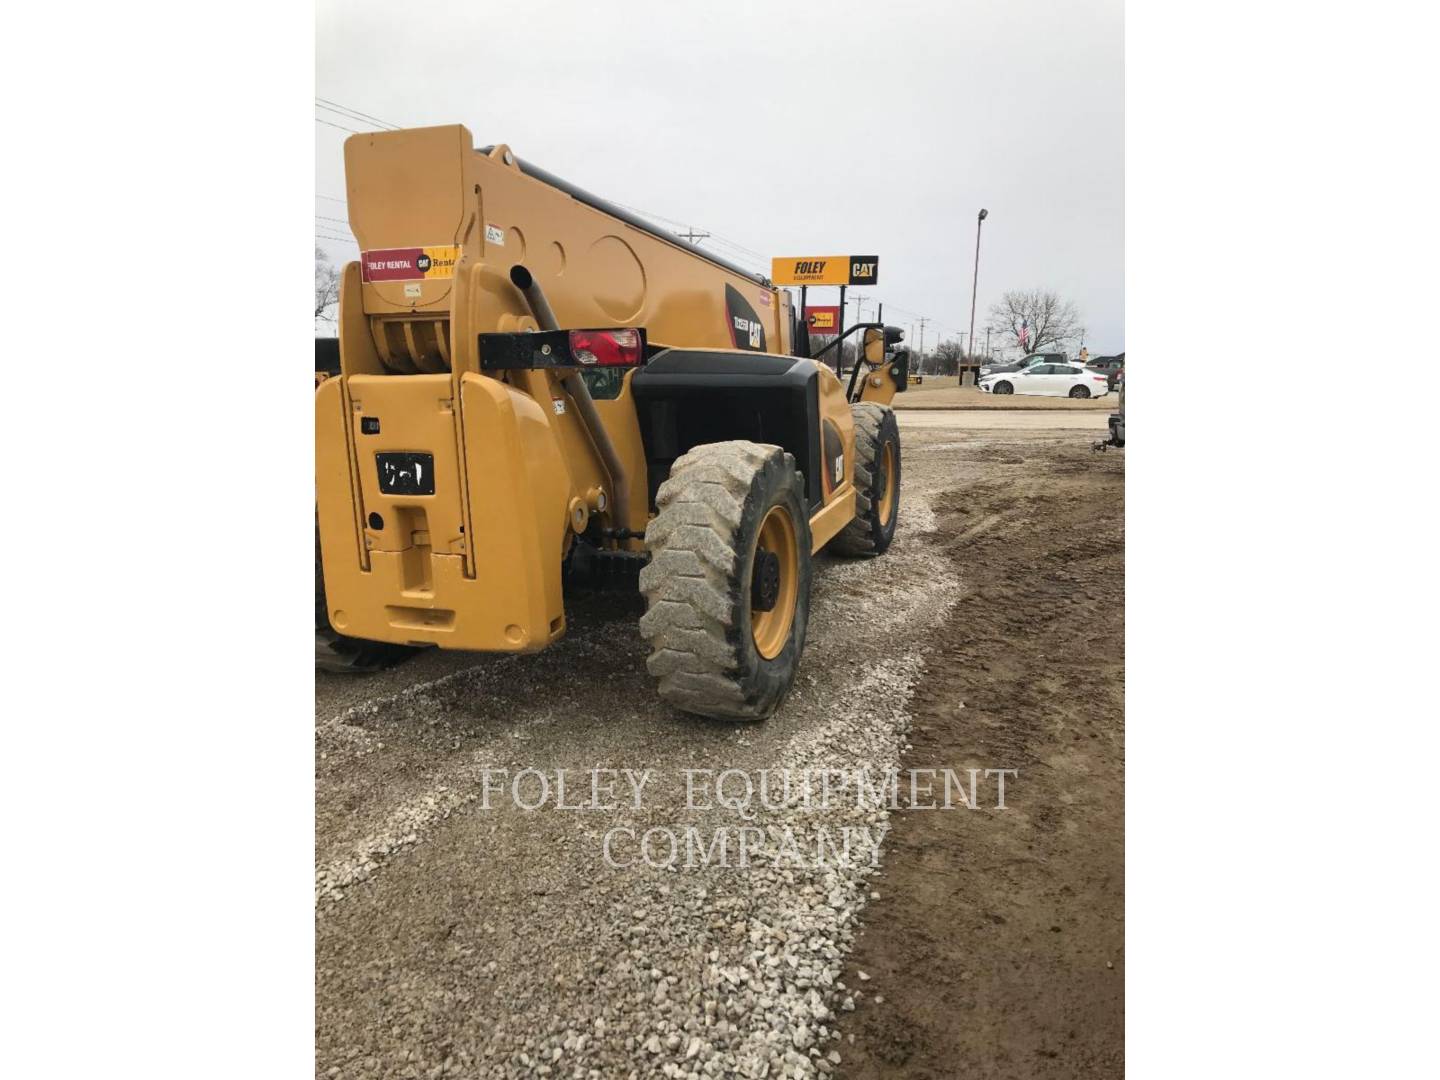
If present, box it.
[841,417,1125,1079]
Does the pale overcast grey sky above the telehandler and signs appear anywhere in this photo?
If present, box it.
[314,0,1125,356]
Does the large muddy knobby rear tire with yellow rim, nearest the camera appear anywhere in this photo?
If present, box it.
[639,442,811,720]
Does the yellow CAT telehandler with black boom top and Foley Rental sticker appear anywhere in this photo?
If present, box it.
[315,125,907,719]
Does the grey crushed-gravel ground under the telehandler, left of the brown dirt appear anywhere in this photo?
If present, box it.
[315,413,1123,1077]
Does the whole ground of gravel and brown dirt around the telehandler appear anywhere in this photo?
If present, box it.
[315,402,1123,1079]
